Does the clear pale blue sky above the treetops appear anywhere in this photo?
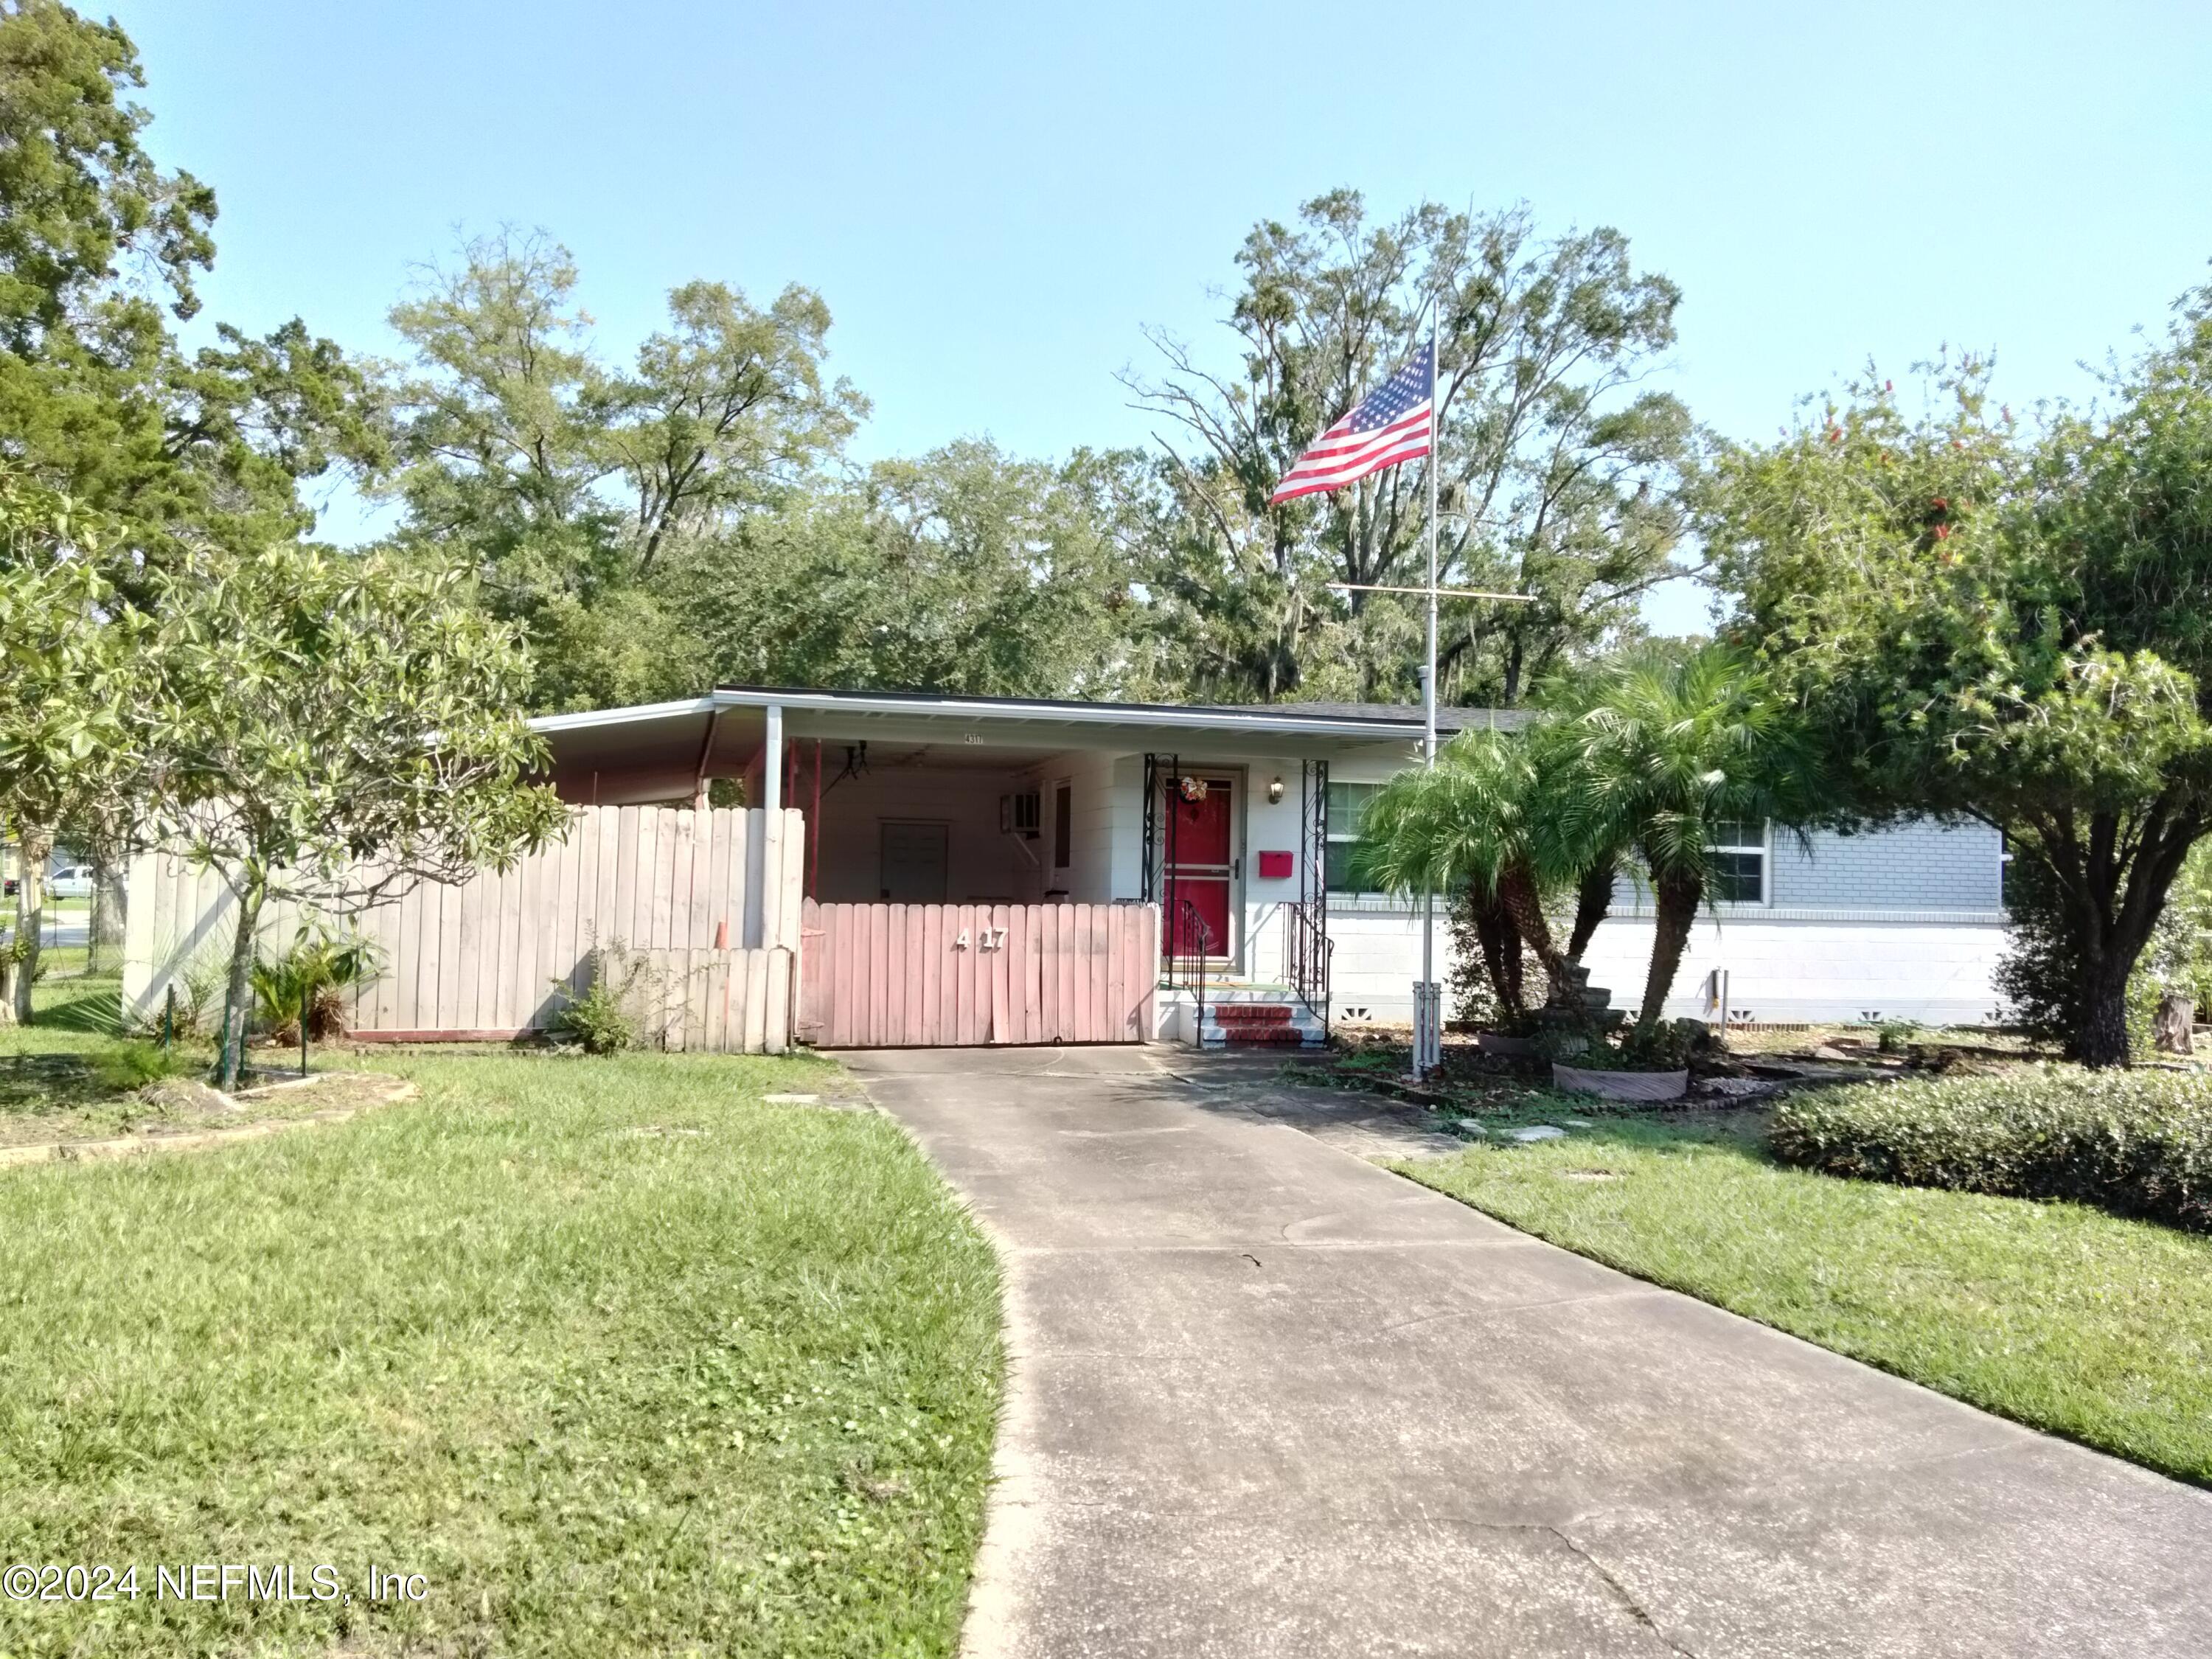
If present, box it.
[115,0,2212,626]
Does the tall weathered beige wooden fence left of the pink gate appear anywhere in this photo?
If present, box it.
[124,807,805,1053]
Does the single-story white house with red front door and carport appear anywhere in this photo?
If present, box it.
[535,686,2004,1040]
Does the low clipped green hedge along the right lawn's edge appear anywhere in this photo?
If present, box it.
[1770,1066,2212,1232]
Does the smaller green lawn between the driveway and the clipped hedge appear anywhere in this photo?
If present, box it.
[1398,1106,2212,1484]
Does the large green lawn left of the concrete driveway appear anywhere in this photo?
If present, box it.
[0,1044,1000,1659]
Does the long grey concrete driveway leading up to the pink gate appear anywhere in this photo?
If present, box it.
[847,1048,2212,1659]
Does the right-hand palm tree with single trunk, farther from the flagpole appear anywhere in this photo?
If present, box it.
[1555,646,1823,1037]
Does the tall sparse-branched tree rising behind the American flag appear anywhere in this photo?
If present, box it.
[1124,190,1705,706]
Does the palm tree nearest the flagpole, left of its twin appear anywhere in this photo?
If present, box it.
[1360,732,1588,1015]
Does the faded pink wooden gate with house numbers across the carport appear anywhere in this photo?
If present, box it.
[796,898,1159,1048]
